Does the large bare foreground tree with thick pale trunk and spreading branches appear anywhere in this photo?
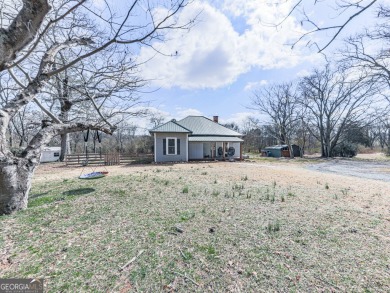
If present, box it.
[0,0,191,214]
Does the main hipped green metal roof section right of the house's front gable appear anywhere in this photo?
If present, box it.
[177,116,243,136]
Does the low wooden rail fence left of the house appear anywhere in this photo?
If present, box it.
[65,153,153,166]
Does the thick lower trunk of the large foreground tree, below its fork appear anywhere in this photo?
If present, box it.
[0,158,37,215]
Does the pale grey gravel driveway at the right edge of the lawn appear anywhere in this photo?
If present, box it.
[307,160,390,182]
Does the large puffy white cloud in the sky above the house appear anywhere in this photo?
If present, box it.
[139,0,318,89]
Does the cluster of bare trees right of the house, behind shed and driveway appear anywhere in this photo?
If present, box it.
[250,60,390,157]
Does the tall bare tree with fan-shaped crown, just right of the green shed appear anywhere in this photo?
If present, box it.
[300,65,376,157]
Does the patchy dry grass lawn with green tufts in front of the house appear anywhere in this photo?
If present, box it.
[0,160,390,292]
